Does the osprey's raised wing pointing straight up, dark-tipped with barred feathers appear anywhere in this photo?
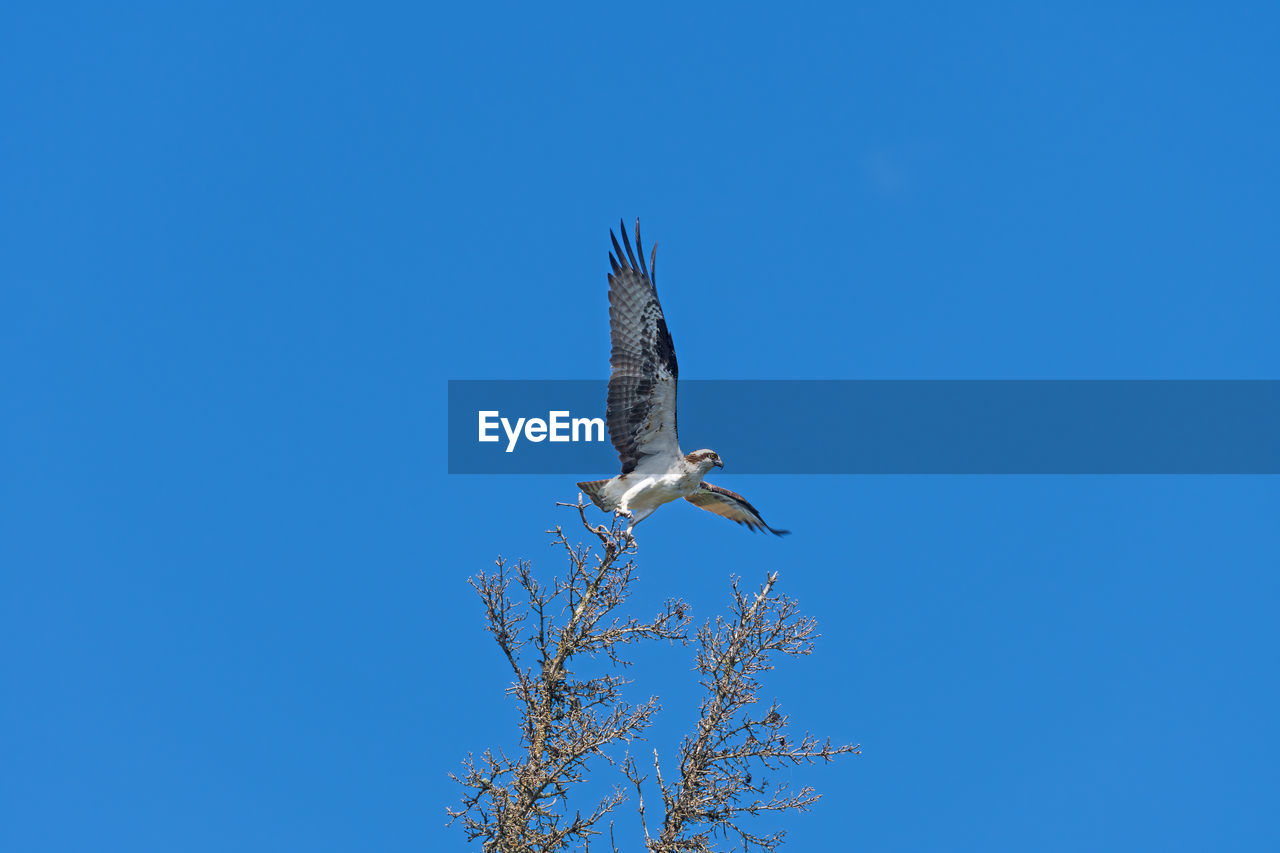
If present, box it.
[605,219,680,474]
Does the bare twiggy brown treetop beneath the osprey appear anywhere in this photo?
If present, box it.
[449,501,858,853]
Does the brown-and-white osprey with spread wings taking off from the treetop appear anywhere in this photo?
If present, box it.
[577,219,788,535]
